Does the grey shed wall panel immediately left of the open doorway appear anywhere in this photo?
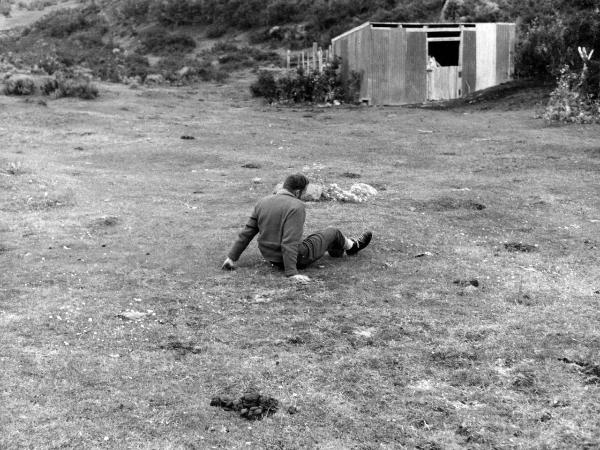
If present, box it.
[404,32,427,103]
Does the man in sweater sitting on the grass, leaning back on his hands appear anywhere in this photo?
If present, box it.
[221,173,373,283]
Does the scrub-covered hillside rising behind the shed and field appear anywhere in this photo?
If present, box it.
[0,0,600,87]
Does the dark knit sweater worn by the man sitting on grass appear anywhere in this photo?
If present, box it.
[228,189,306,277]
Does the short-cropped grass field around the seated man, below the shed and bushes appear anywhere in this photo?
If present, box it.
[0,75,600,449]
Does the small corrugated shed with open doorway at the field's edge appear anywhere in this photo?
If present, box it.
[332,22,516,105]
